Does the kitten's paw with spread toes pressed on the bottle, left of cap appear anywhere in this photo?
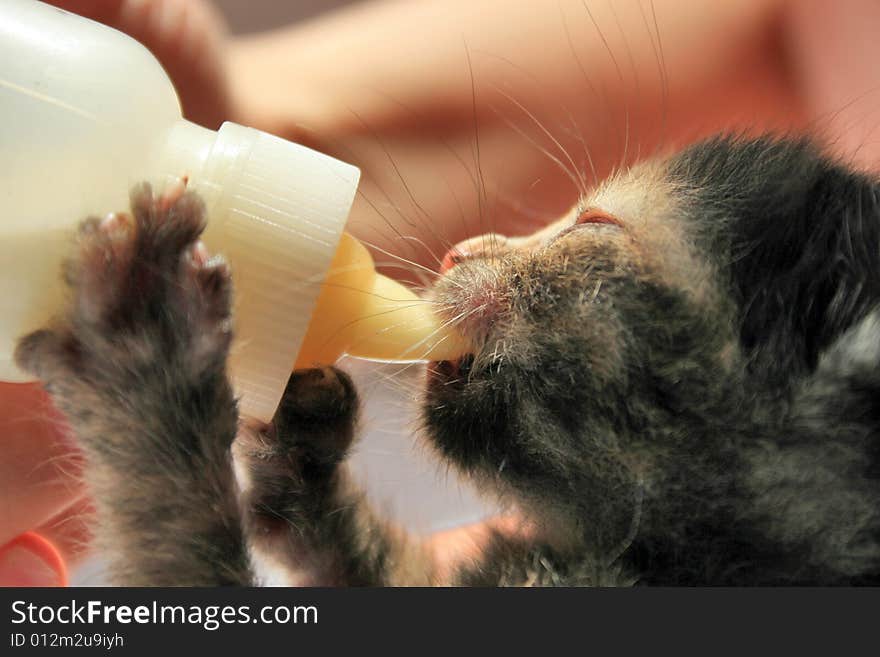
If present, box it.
[16,183,231,384]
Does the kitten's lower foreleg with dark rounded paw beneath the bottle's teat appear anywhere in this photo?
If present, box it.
[235,367,433,586]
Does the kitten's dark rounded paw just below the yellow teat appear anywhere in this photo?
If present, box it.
[272,367,358,466]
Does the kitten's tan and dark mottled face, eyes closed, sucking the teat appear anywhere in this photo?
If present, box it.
[427,155,736,524]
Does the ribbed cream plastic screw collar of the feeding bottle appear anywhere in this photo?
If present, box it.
[193,123,360,422]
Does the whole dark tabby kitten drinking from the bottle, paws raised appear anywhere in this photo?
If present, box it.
[17,137,880,585]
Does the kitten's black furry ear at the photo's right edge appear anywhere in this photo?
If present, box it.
[716,142,880,377]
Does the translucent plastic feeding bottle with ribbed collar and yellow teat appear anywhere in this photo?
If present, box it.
[0,0,465,421]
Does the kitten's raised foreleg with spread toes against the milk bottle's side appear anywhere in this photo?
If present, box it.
[16,185,251,585]
